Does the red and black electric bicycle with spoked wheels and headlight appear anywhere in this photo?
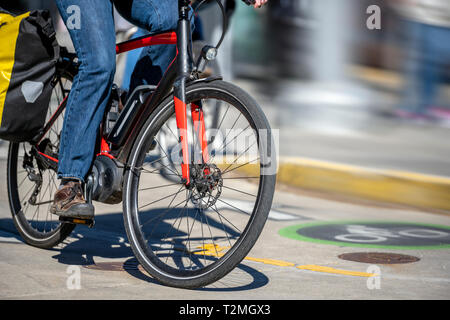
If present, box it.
[7,0,276,288]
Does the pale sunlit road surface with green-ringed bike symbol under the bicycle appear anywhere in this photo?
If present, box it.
[0,160,450,300]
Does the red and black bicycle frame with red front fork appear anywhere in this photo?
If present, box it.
[35,0,208,185]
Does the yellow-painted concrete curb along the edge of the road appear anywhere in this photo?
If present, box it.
[277,158,450,211]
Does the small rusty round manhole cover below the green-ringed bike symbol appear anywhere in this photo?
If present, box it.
[338,252,420,264]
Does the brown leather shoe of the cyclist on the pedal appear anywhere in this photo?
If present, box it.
[50,181,94,219]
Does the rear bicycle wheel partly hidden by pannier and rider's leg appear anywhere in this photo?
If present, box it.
[7,77,75,249]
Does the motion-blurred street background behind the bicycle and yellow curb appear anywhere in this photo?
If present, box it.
[0,0,450,176]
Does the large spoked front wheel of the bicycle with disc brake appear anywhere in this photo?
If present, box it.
[123,81,276,288]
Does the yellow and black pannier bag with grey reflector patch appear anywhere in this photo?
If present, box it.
[0,8,59,142]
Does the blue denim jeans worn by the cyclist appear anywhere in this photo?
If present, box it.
[56,0,178,181]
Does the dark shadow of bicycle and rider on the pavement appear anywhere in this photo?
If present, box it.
[0,210,269,291]
